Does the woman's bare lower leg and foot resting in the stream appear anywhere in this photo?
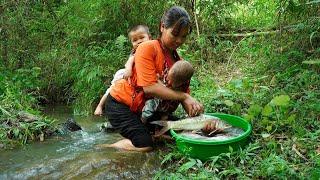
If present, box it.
[97,139,152,152]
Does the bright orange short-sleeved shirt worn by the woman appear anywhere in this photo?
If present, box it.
[110,40,165,107]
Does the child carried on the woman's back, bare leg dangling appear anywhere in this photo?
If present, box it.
[94,25,151,116]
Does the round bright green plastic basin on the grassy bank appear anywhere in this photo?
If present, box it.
[170,113,252,160]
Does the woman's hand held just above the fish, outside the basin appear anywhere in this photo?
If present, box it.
[182,93,203,117]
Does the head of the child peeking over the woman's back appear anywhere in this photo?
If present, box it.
[128,25,151,50]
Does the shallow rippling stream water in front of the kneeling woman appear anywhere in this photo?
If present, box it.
[0,106,161,179]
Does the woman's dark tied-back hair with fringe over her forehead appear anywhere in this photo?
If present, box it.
[159,6,192,35]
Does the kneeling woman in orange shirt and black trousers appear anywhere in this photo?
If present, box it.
[102,6,203,151]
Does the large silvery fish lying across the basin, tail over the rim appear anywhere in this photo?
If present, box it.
[150,114,231,136]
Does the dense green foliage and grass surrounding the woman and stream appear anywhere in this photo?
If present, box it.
[0,0,320,179]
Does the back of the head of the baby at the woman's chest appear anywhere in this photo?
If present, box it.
[168,61,194,88]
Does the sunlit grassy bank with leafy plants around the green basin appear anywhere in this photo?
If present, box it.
[155,29,320,179]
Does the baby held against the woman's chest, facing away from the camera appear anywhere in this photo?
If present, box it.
[141,60,194,123]
